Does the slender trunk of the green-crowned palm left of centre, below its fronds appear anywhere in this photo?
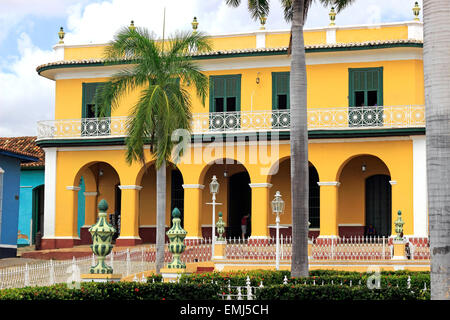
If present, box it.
[156,161,166,274]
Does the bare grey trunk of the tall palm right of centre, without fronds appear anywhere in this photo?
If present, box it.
[290,0,309,277]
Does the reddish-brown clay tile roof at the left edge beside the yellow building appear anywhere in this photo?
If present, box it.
[0,137,44,168]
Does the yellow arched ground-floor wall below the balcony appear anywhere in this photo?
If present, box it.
[56,139,414,240]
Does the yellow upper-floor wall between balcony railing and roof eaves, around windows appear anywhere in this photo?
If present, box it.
[55,60,425,119]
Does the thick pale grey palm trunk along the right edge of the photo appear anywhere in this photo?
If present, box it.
[423,0,450,300]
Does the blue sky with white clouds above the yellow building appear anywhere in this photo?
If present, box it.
[0,0,422,136]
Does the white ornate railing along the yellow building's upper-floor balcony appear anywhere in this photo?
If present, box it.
[37,105,425,140]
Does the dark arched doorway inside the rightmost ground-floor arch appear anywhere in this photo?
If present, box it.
[365,174,392,237]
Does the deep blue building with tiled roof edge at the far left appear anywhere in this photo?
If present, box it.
[0,138,38,258]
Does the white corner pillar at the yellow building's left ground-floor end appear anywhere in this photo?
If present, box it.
[43,148,57,239]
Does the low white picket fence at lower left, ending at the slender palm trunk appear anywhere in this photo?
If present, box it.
[0,248,154,289]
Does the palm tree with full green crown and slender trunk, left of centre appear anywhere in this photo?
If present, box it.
[95,27,211,273]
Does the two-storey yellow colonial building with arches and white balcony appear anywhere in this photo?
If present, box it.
[33,10,428,248]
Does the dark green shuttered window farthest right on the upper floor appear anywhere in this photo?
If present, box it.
[349,68,383,107]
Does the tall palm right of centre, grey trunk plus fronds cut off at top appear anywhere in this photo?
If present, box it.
[225,0,354,277]
